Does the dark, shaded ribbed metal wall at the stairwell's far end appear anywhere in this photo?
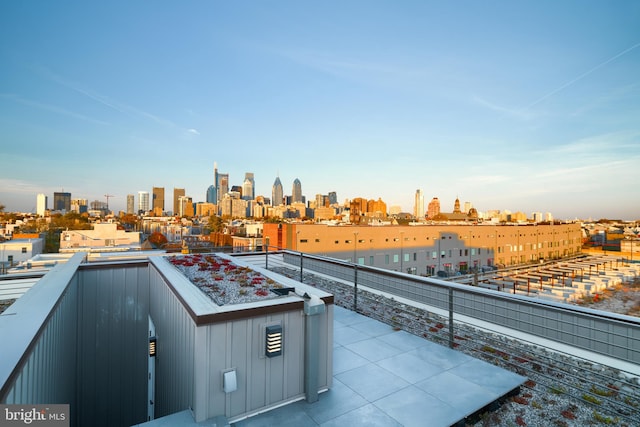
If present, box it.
[77,264,149,427]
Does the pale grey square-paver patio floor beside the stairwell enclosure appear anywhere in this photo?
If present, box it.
[232,306,526,427]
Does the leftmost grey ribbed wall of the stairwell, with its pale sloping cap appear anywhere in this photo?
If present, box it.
[0,254,83,425]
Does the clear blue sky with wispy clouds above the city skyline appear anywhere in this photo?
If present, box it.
[0,0,640,219]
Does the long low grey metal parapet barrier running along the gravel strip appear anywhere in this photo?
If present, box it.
[282,251,640,364]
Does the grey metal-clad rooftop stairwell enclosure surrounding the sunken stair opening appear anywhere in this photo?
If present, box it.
[0,254,333,426]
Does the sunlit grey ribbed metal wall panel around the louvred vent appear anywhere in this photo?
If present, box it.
[191,310,304,421]
